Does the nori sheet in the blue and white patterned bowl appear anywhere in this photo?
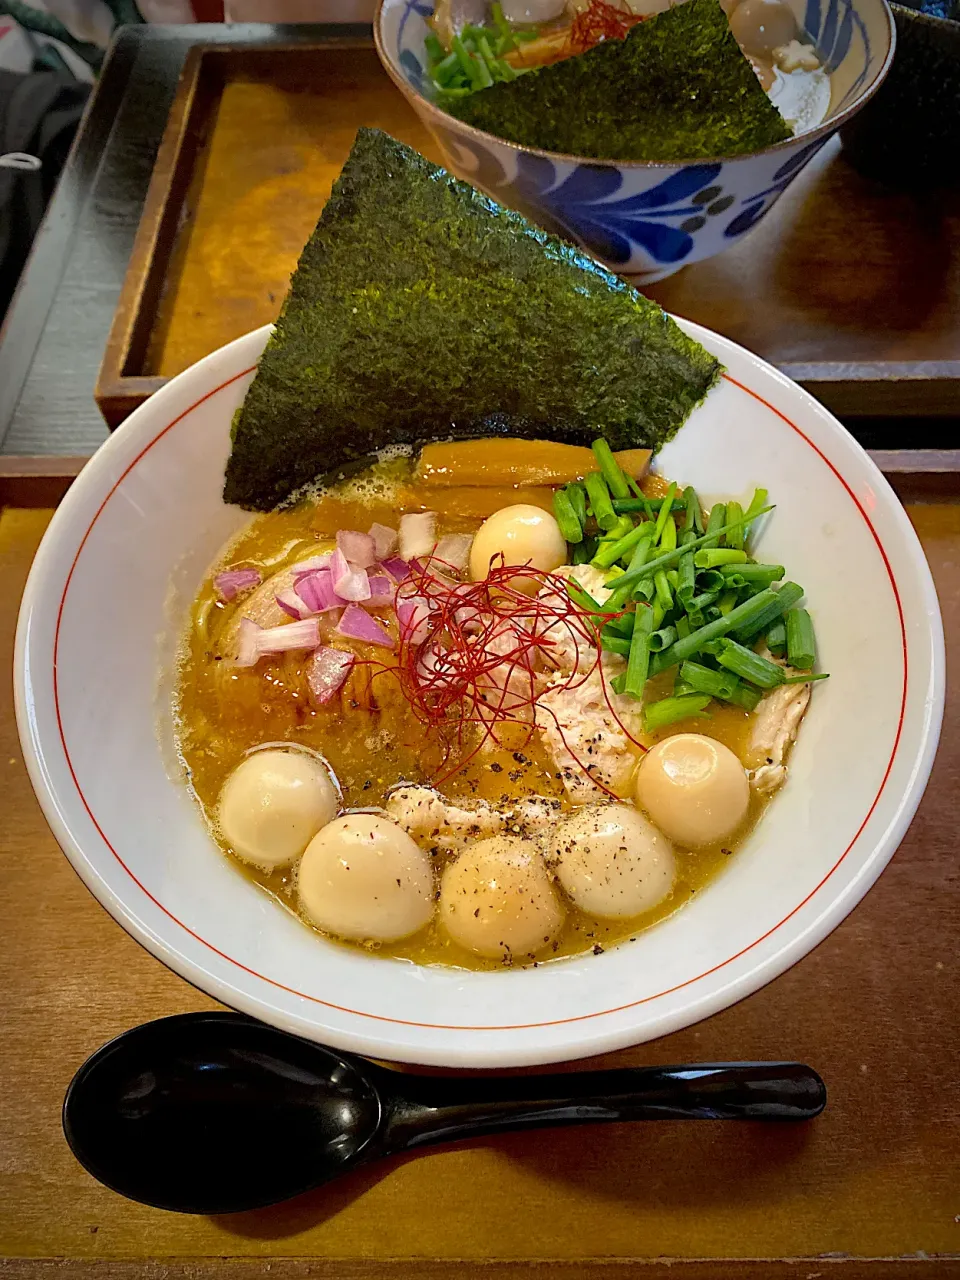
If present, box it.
[438,0,792,161]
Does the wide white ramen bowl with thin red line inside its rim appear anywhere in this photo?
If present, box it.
[15,323,943,1068]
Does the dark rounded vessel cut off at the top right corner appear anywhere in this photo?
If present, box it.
[841,0,960,191]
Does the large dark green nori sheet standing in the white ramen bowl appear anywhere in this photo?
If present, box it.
[224,128,721,511]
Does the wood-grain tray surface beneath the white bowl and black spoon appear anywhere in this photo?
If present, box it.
[0,503,960,1280]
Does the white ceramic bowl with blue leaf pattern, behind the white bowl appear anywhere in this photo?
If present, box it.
[374,0,895,284]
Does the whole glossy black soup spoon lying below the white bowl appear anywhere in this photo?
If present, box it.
[63,1014,827,1213]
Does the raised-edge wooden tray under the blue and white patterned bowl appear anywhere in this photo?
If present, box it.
[96,38,960,430]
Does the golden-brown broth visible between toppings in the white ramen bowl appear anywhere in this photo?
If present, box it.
[175,460,763,970]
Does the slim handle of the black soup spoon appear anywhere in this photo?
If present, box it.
[380,1062,827,1151]
